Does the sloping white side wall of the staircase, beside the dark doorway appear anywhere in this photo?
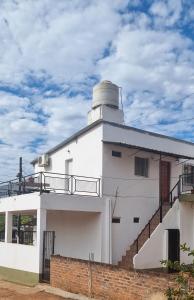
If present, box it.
[133,200,180,269]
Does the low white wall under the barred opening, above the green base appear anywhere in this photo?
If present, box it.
[0,242,39,273]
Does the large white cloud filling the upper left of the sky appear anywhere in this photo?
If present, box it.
[0,0,120,84]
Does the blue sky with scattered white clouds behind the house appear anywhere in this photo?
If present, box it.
[0,0,194,180]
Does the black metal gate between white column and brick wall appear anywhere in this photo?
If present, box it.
[42,231,55,282]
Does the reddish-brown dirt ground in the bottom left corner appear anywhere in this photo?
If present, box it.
[0,281,71,300]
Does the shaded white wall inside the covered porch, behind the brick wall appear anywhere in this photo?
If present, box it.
[47,211,102,261]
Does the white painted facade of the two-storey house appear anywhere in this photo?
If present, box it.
[0,79,194,282]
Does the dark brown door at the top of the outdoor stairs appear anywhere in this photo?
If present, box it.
[160,160,170,202]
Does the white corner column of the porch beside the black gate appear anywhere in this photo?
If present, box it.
[36,208,47,274]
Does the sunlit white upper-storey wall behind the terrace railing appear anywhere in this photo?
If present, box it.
[35,125,102,177]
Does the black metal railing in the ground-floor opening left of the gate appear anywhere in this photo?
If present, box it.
[12,230,36,245]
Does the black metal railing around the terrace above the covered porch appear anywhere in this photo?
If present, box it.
[0,172,100,198]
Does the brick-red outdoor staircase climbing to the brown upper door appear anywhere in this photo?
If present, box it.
[118,180,180,270]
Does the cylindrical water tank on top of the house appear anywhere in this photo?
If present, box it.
[92,80,119,108]
